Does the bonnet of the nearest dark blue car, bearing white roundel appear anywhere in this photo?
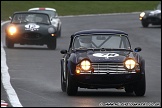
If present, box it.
[75,51,133,63]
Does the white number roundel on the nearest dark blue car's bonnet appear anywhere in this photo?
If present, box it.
[93,53,119,59]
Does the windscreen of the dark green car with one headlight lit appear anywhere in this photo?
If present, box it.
[11,13,50,24]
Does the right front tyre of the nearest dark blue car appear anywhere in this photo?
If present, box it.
[134,60,146,96]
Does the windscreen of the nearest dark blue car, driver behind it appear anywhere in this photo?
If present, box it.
[72,34,131,49]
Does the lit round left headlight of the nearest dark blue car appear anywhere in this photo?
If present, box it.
[80,60,91,71]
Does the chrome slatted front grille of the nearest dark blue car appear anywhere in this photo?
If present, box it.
[88,63,135,74]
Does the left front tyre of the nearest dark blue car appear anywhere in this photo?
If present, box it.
[66,72,78,96]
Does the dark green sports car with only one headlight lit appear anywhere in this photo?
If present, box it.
[5,11,56,49]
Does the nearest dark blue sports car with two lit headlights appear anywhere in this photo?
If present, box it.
[61,29,146,96]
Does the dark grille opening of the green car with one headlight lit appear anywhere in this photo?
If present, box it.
[23,33,42,40]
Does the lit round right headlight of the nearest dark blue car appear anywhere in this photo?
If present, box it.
[124,59,136,70]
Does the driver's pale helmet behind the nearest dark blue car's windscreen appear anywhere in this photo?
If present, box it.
[79,36,92,48]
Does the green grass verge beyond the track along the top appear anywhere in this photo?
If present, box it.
[1,1,160,20]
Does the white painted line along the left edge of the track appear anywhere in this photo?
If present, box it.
[1,22,22,107]
